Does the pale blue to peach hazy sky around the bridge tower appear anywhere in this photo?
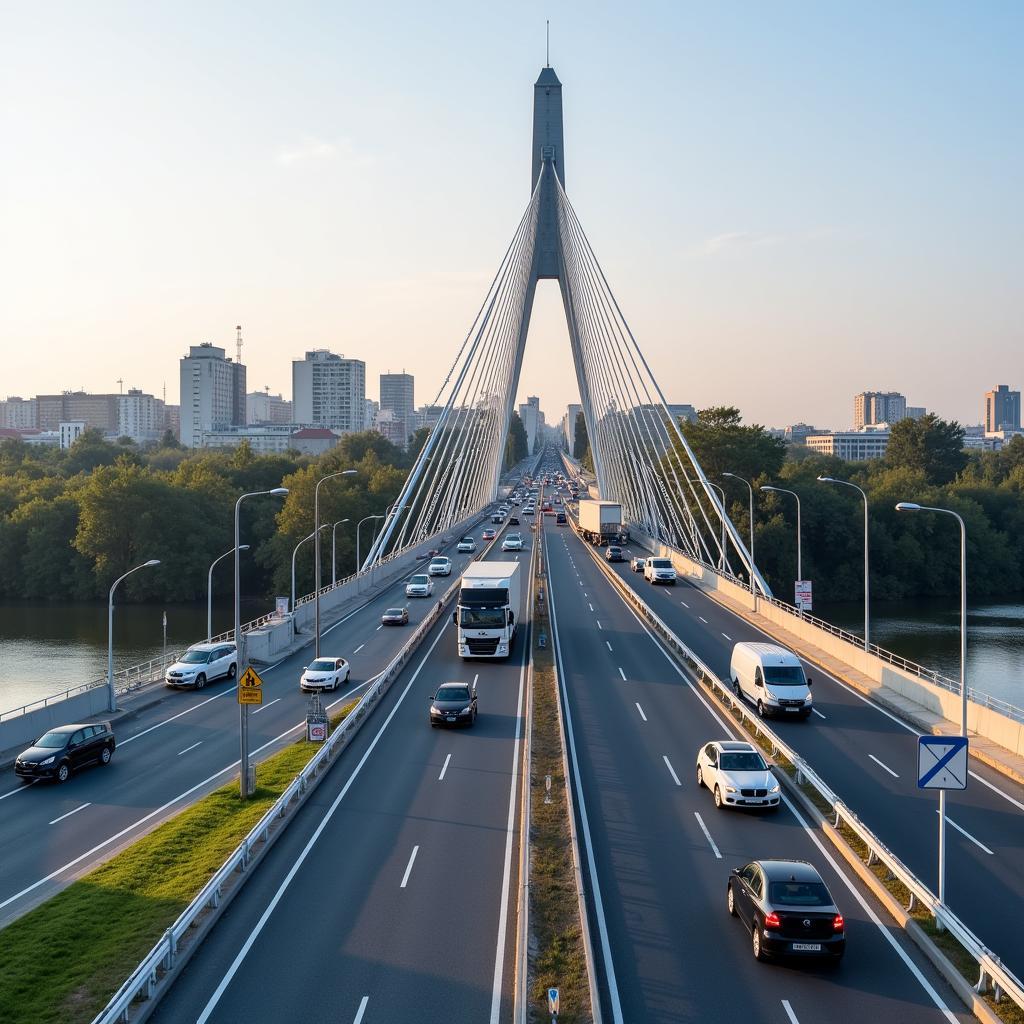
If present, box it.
[0,0,1024,427]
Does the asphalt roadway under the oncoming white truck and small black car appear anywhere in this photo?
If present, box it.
[154,530,529,1024]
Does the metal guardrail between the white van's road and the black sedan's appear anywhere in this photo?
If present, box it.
[573,526,1024,1010]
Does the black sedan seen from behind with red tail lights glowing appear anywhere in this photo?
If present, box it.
[727,860,846,963]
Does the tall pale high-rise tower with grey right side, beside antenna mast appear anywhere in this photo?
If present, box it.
[180,341,246,447]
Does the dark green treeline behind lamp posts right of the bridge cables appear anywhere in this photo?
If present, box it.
[683,408,1024,602]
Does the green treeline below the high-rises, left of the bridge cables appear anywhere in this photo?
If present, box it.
[0,431,417,601]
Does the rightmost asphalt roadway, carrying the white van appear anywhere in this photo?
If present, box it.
[598,549,1024,976]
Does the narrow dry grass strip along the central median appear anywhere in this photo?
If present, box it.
[528,540,592,1024]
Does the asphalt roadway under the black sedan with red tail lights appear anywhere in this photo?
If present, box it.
[546,527,971,1024]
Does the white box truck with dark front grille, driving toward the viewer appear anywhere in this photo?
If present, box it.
[452,562,519,657]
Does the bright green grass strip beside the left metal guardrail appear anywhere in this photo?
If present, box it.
[0,701,355,1024]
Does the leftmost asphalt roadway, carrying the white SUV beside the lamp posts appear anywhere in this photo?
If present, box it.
[0,524,495,927]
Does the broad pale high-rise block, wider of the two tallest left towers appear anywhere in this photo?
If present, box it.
[292,348,367,433]
